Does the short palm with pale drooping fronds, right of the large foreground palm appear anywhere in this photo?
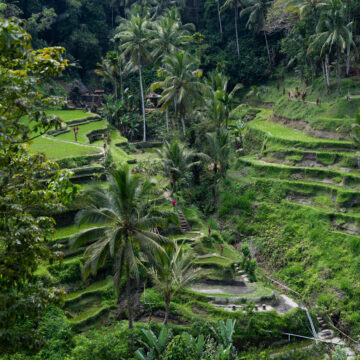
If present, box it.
[148,246,202,325]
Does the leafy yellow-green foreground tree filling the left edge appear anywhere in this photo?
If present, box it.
[0,16,74,354]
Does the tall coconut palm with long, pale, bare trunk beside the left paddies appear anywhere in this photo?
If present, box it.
[115,14,150,142]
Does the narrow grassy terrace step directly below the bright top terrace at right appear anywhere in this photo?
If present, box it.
[263,147,360,172]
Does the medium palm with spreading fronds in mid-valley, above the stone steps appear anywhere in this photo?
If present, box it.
[158,140,205,197]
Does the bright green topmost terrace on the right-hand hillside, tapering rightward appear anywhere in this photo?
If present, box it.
[246,117,353,151]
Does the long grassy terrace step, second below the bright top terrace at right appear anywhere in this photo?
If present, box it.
[238,156,360,188]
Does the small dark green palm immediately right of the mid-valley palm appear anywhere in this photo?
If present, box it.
[206,128,230,177]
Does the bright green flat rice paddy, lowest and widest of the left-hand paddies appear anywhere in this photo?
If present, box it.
[30,137,102,160]
